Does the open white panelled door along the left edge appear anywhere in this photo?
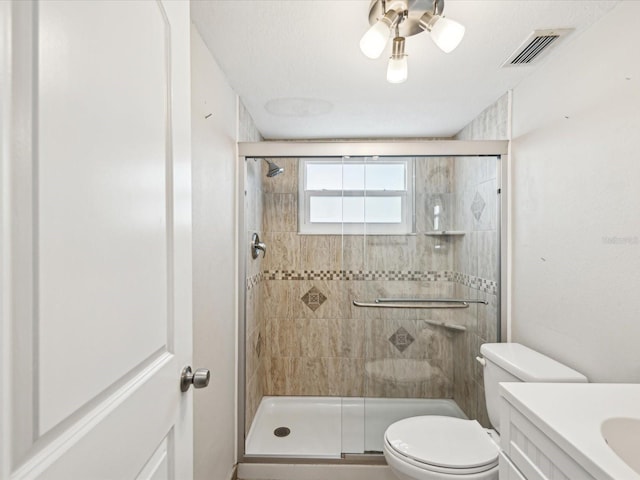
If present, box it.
[0,0,192,480]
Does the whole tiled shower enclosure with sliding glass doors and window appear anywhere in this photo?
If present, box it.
[239,141,505,462]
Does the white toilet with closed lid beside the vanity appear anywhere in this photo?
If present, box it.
[383,343,587,480]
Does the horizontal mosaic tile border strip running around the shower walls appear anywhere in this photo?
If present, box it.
[260,270,498,295]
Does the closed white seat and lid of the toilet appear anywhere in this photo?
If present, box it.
[384,415,499,475]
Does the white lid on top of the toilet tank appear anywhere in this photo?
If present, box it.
[480,343,588,383]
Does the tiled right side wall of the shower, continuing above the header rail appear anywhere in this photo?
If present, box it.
[453,94,508,426]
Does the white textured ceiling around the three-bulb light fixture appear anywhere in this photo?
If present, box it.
[191,0,618,139]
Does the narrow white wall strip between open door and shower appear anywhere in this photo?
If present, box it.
[189,26,244,480]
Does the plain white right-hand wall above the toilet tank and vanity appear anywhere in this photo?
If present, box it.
[511,2,640,382]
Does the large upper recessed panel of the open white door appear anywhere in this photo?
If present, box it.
[35,2,173,434]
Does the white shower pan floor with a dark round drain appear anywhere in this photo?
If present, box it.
[245,397,467,458]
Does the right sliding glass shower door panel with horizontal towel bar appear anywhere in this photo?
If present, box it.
[360,157,498,453]
